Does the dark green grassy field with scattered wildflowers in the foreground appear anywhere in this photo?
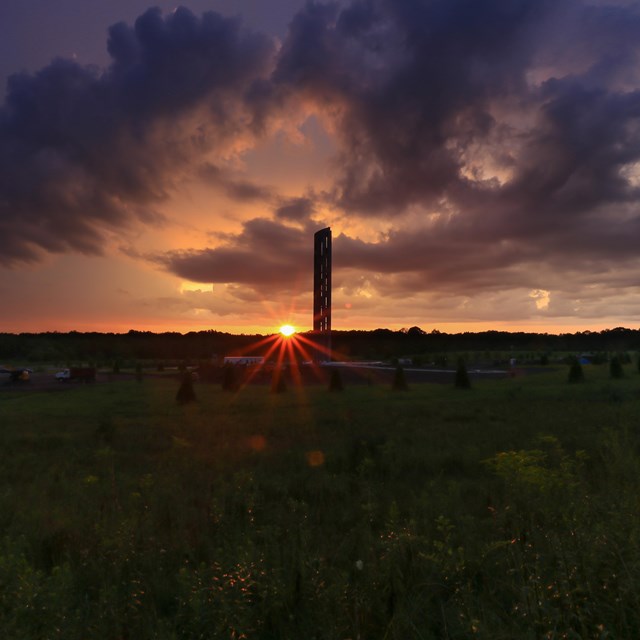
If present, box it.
[0,366,640,640]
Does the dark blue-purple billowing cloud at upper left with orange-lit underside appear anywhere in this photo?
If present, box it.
[0,8,274,265]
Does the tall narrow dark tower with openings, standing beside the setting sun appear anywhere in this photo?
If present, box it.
[313,227,331,360]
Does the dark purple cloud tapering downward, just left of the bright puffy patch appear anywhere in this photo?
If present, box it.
[274,0,549,215]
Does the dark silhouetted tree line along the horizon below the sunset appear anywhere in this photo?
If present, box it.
[0,327,640,362]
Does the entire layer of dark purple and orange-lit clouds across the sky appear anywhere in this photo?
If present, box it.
[0,0,640,328]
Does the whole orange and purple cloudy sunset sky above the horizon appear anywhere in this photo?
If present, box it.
[0,0,640,333]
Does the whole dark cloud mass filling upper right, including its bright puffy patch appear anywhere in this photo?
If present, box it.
[274,0,640,230]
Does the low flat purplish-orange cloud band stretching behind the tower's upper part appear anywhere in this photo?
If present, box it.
[151,200,640,298]
